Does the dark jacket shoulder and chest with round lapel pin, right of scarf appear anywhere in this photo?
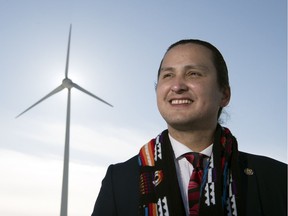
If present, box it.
[239,152,287,216]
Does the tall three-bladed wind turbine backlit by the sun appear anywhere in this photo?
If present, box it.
[16,25,113,216]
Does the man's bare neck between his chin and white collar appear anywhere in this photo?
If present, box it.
[168,125,216,152]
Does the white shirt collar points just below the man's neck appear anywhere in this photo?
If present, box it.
[168,134,213,159]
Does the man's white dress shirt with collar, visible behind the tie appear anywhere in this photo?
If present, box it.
[169,134,213,215]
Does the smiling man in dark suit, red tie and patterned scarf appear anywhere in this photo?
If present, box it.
[92,40,287,216]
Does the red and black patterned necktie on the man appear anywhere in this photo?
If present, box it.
[183,152,205,216]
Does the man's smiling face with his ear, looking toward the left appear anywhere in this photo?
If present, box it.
[156,44,230,131]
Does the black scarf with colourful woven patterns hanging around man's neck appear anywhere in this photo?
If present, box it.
[138,125,241,216]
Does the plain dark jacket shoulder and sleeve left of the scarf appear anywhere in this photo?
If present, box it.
[92,156,139,216]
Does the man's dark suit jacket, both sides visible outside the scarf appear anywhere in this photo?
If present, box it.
[92,152,287,216]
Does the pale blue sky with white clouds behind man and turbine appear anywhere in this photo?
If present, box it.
[0,0,287,216]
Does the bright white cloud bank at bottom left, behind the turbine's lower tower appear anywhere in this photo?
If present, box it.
[0,150,106,216]
